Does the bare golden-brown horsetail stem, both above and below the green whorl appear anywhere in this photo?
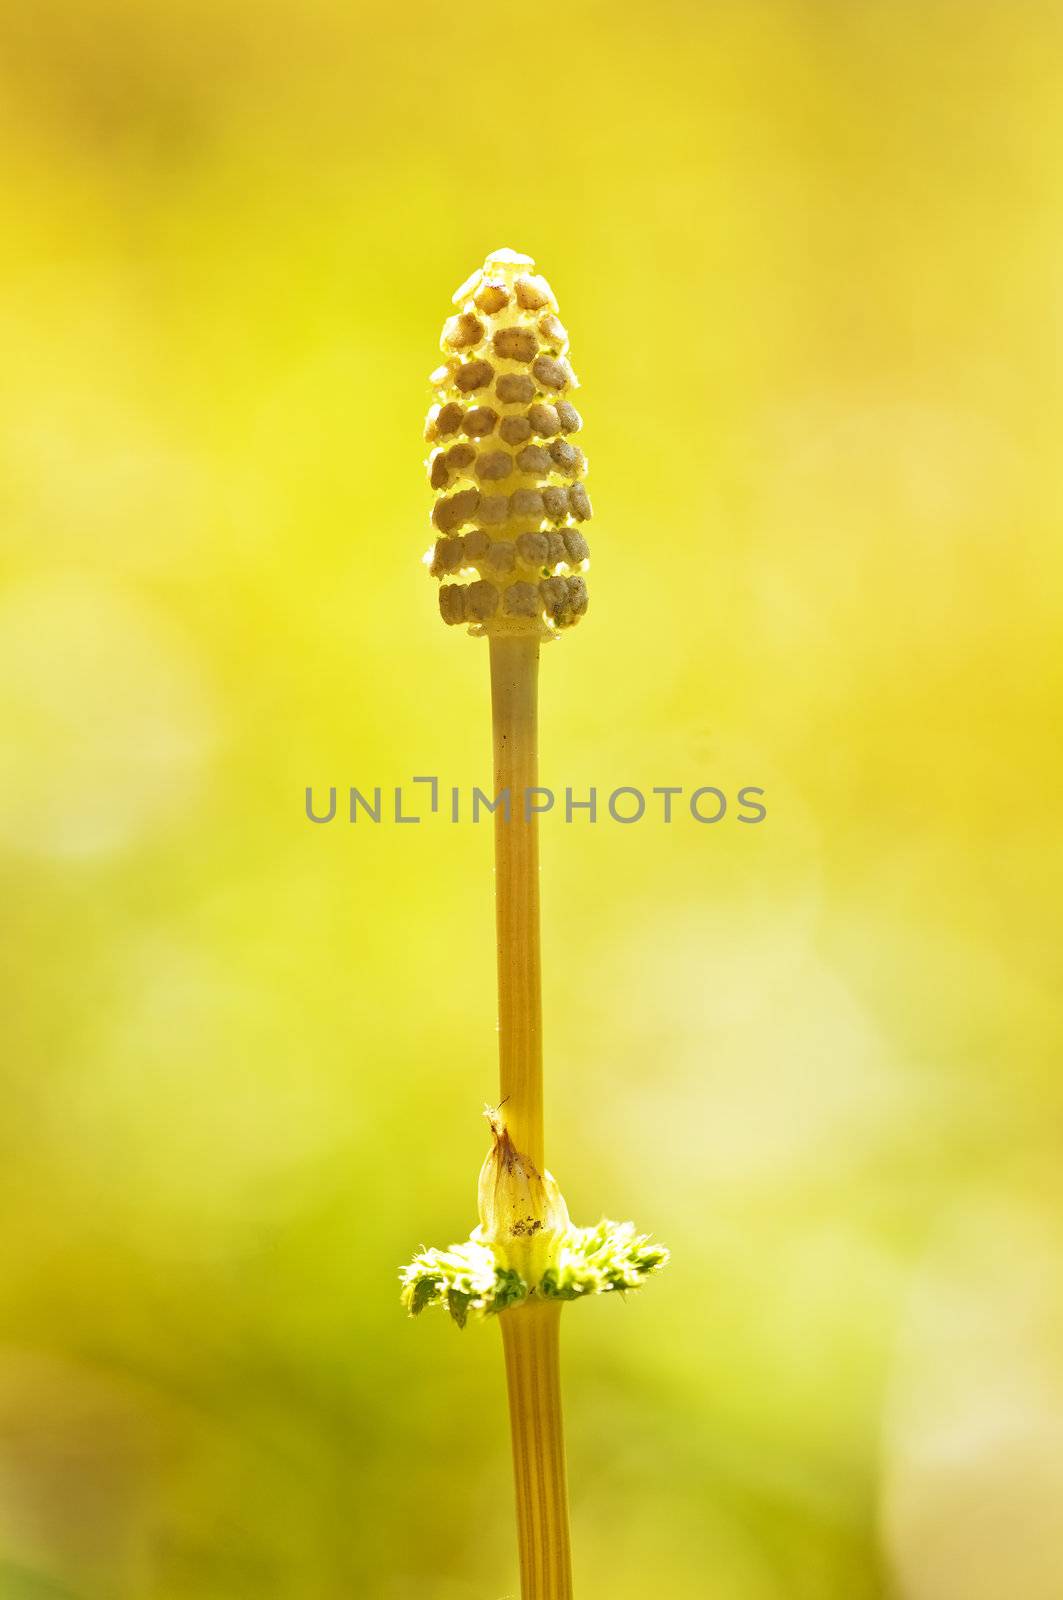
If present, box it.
[490,635,572,1600]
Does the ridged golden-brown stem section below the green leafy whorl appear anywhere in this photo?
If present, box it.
[499,1299,572,1600]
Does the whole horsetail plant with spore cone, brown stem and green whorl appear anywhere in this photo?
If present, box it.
[402,250,668,1600]
